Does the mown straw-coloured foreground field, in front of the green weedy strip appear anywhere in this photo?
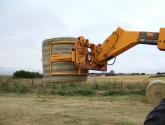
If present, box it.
[0,94,153,125]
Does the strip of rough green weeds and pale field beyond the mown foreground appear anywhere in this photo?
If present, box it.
[0,75,165,96]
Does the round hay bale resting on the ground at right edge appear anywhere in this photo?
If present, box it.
[146,80,165,105]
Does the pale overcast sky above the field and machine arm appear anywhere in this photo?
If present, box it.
[0,0,165,73]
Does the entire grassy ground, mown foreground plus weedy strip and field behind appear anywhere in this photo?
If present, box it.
[0,75,165,125]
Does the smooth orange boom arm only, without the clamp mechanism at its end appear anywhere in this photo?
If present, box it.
[98,28,165,61]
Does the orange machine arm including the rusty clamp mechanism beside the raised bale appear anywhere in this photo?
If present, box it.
[72,27,165,70]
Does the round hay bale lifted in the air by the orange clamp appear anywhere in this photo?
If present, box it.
[42,37,87,84]
